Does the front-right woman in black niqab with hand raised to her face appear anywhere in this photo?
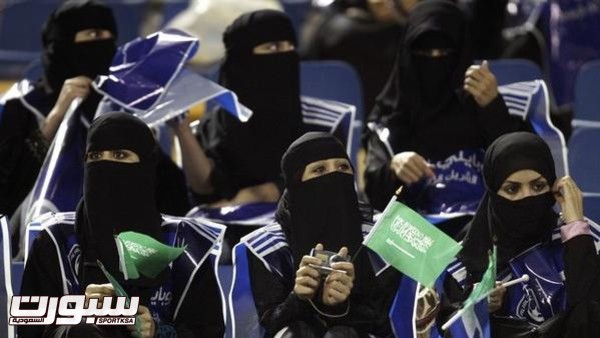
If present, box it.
[447,132,600,337]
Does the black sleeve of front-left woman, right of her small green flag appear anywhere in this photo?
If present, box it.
[175,262,225,338]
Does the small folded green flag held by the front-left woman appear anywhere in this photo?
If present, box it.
[115,231,185,280]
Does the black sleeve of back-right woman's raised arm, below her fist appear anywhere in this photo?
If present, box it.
[474,94,532,148]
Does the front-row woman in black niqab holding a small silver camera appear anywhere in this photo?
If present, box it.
[250,132,389,337]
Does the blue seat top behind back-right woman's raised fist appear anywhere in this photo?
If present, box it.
[490,59,543,86]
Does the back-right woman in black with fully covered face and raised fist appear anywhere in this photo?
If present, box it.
[364,0,526,210]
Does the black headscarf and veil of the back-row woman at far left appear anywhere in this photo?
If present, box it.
[42,0,117,92]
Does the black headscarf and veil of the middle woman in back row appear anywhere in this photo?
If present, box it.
[214,10,302,193]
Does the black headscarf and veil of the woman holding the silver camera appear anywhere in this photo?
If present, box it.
[276,132,373,290]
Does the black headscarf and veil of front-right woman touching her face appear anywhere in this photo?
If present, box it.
[460,132,558,281]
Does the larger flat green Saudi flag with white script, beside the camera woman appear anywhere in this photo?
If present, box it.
[363,197,462,288]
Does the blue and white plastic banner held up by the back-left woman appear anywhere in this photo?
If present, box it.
[94,29,252,127]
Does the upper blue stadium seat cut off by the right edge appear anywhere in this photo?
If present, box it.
[572,60,600,128]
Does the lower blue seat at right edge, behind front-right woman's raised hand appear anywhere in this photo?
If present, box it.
[569,128,600,193]
